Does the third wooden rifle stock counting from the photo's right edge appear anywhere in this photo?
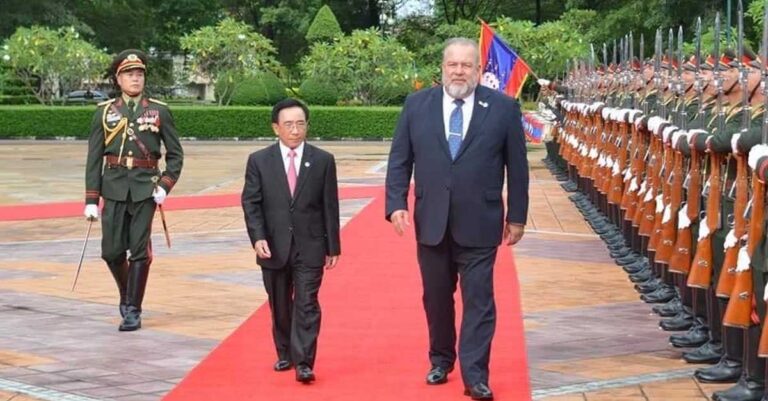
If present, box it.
[715,155,749,298]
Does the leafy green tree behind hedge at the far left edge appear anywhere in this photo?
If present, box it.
[2,26,109,104]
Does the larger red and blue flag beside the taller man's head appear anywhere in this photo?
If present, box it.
[480,20,531,98]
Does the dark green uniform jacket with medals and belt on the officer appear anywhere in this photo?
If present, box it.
[85,97,184,204]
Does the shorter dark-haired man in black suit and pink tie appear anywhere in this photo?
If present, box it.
[242,99,341,383]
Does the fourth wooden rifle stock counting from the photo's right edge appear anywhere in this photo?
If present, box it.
[687,153,722,290]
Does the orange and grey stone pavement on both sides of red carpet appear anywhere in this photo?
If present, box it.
[0,141,727,401]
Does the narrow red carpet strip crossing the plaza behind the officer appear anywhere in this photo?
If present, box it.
[0,186,380,221]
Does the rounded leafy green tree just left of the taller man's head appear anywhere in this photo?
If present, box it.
[300,28,417,105]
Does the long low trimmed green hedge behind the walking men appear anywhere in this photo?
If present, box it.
[0,105,400,139]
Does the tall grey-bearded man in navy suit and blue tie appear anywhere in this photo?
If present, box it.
[386,38,528,399]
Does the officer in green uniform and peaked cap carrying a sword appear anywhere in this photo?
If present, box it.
[85,50,184,331]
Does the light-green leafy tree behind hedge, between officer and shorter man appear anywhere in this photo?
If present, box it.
[181,18,279,105]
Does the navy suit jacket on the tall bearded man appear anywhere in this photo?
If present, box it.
[386,86,528,247]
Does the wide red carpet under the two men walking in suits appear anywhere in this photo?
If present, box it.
[165,193,531,401]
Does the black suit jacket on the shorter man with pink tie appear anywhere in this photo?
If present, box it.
[242,143,341,269]
